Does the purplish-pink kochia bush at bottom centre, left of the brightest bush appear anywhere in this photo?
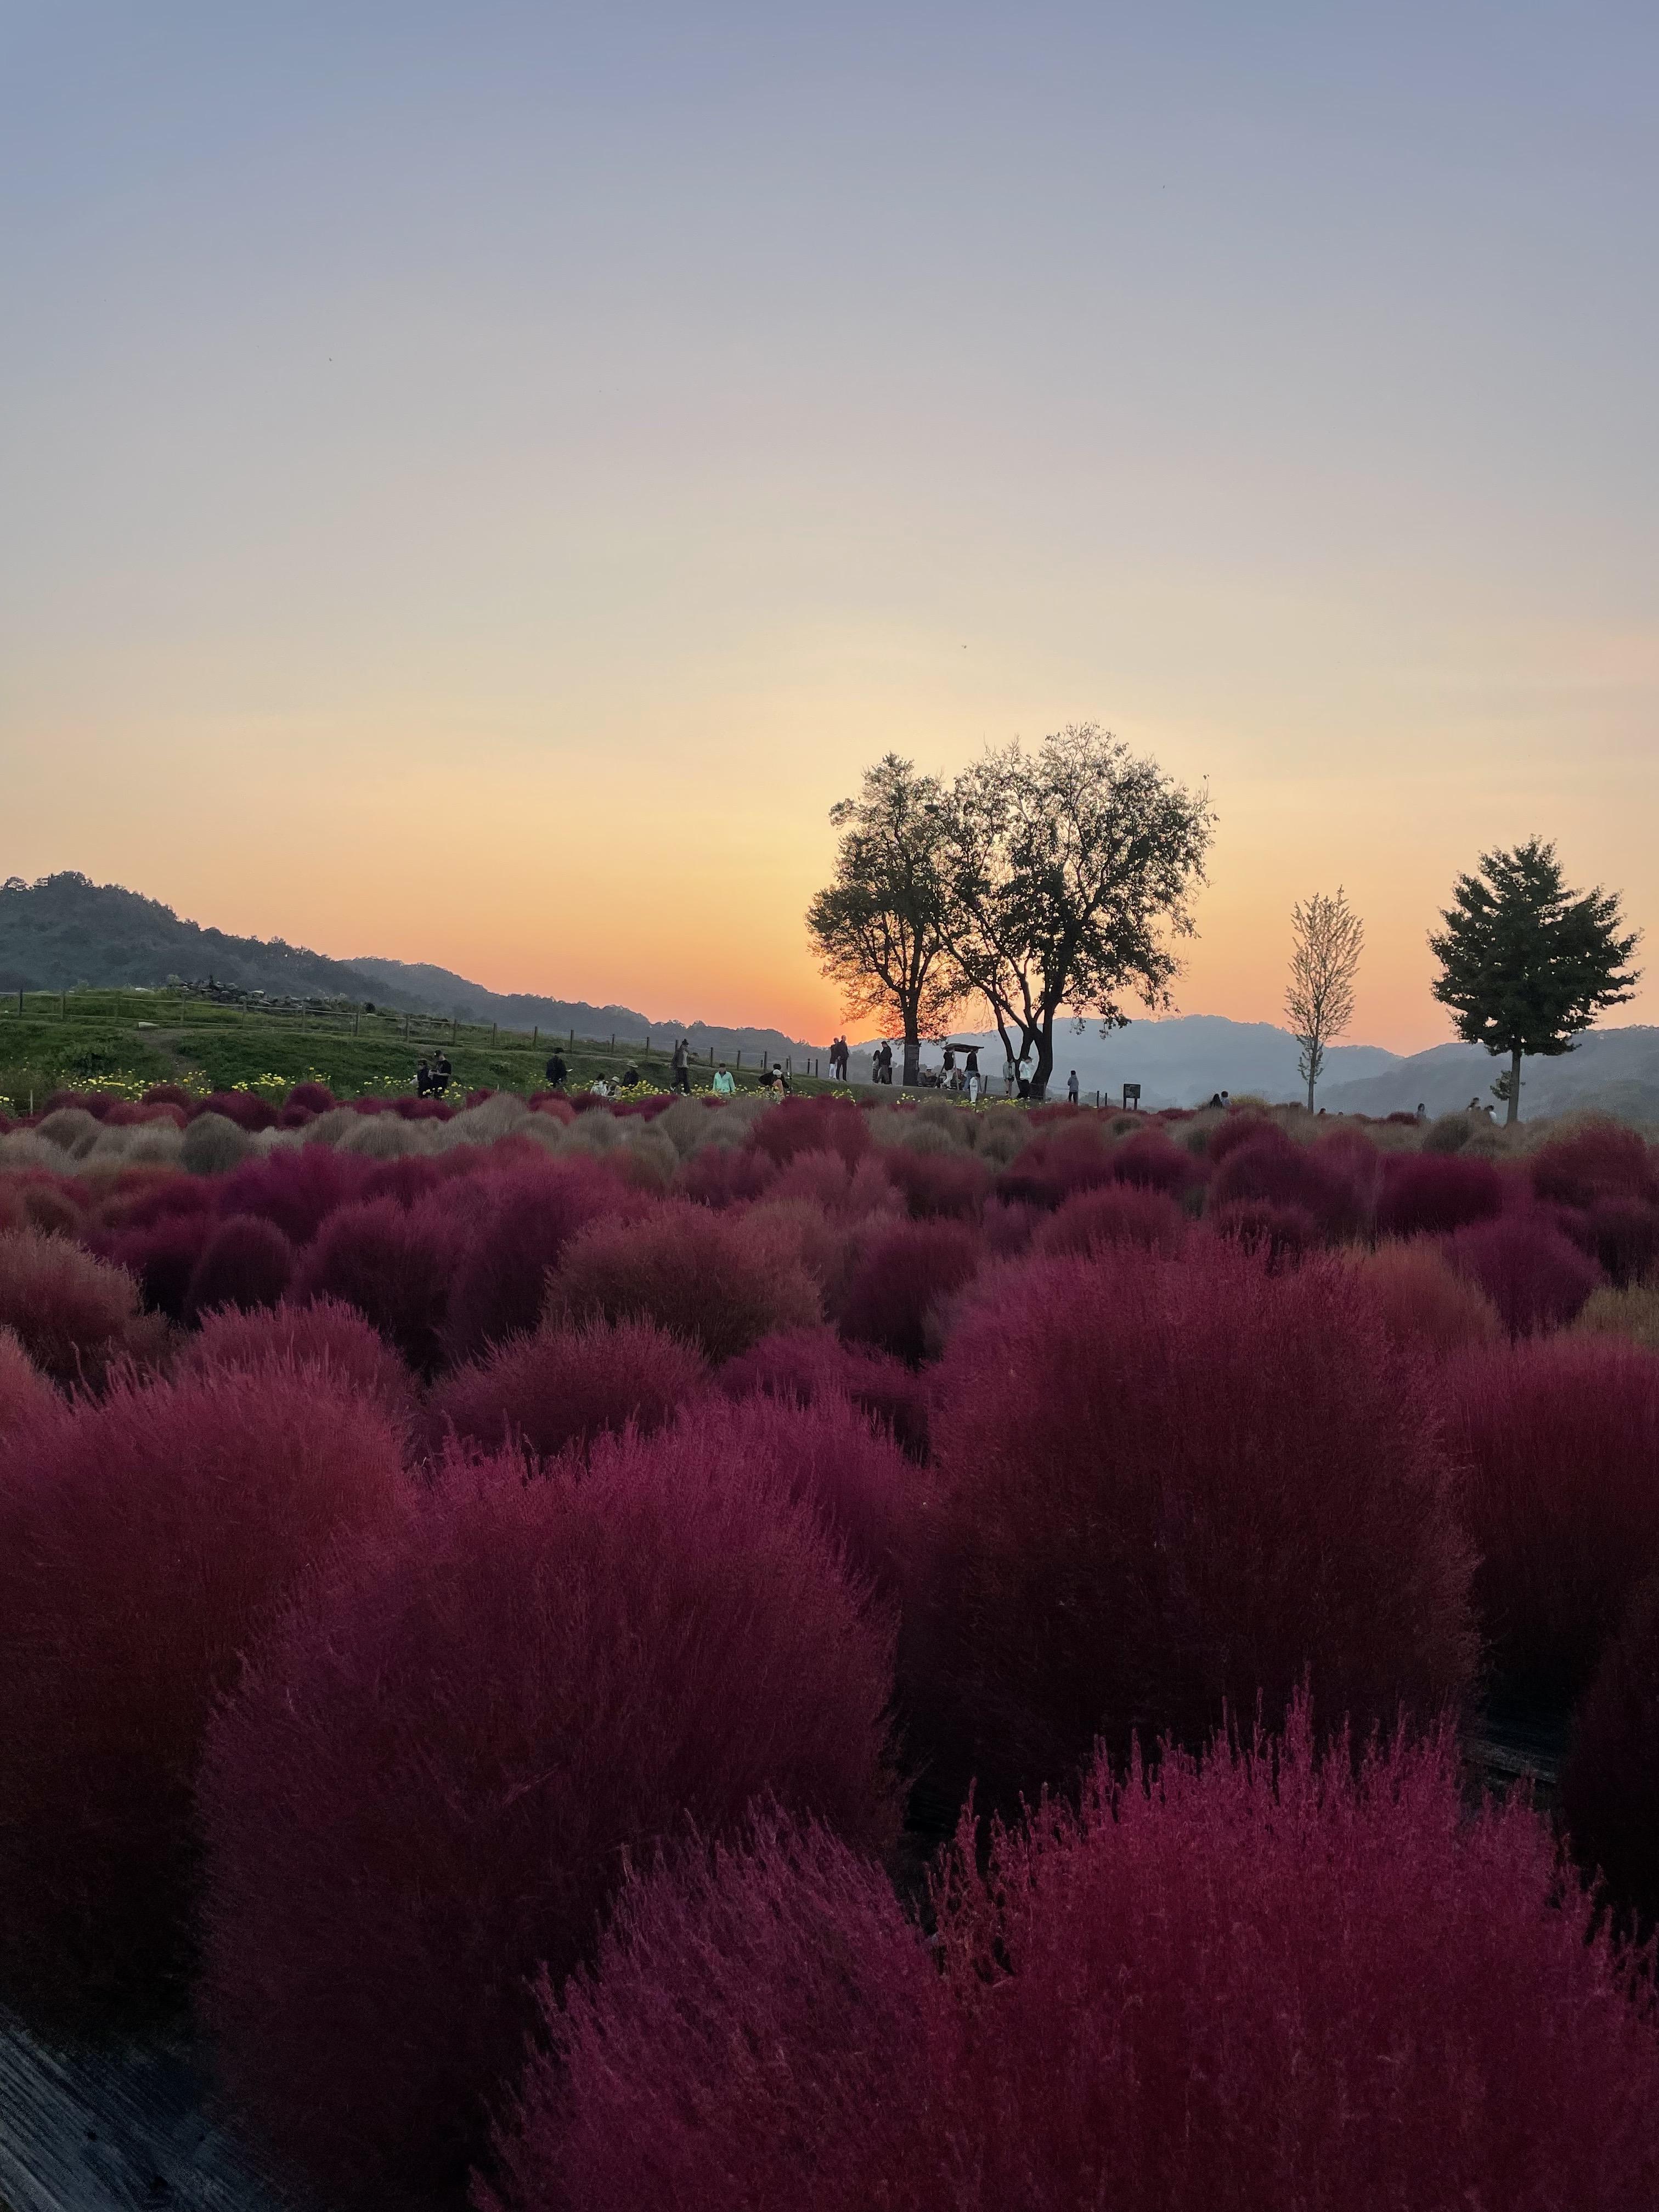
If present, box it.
[473,1809,946,2212]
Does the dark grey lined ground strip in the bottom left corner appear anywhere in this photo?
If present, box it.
[0,2011,296,2212]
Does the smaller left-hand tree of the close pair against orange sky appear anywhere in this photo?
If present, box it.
[808,752,956,1084]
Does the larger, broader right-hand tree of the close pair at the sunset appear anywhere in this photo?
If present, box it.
[949,723,1212,1097]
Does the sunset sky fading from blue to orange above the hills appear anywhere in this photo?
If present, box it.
[0,0,1659,1051]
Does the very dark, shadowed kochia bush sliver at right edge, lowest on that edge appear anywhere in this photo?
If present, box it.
[1562,1577,1659,1936]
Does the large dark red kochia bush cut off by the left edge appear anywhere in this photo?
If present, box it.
[0,1369,398,2019]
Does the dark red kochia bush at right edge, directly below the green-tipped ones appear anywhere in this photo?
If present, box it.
[1444,1334,1659,1697]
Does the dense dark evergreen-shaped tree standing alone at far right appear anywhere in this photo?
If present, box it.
[1429,838,1641,1121]
